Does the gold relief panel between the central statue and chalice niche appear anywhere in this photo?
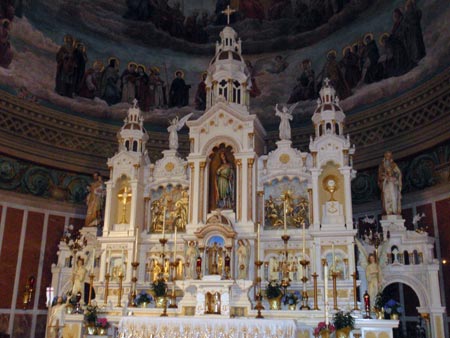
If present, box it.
[264,177,310,230]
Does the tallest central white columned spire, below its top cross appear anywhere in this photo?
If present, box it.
[205,13,251,114]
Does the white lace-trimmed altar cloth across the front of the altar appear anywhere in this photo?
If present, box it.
[119,317,296,338]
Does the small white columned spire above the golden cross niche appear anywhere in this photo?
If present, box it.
[117,99,148,153]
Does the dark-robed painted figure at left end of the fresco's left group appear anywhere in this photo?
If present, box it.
[55,34,75,97]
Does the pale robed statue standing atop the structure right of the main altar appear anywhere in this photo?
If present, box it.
[378,151,402,215]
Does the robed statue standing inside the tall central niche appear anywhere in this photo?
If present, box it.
[215,151,235,209]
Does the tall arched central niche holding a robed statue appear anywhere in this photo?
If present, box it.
[209,143,236,211]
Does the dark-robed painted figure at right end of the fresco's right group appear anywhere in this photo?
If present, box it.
[404,0,426,64]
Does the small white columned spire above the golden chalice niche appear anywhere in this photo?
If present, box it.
[312,78,345,137]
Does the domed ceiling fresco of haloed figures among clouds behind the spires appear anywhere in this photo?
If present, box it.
[0,0,450,129]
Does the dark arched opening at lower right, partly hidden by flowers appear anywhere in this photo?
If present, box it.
[383,283,426,338]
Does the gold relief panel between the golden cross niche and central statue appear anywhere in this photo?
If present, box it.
[150,185,189,233]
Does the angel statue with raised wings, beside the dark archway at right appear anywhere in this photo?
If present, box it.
[355,238,389,304]
